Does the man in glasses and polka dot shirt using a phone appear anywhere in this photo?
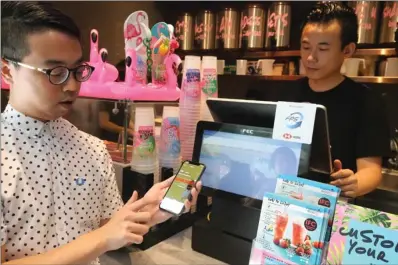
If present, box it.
[1,1,200,264]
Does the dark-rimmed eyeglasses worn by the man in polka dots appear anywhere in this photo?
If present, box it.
[4,58,95,85]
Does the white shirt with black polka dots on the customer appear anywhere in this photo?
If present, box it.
[1,105,123,264]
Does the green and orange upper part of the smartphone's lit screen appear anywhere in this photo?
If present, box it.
[165,162,204,203]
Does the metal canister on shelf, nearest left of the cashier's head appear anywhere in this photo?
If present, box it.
[265,2,292,48]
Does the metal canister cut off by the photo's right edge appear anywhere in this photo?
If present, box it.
[379,1,398,43]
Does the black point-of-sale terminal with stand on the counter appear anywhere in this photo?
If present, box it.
[192,99,332,264]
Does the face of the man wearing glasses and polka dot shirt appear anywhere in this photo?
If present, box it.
[4,30,82,120]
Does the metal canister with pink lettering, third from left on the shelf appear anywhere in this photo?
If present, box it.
[216,8,239,49]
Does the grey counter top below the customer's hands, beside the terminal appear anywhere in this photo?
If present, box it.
[100,228,226,265]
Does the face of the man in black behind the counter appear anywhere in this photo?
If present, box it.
[300,21,355,80]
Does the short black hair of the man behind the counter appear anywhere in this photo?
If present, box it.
[301,2,358,49]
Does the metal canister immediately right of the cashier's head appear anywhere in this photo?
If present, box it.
[348,1,379,44]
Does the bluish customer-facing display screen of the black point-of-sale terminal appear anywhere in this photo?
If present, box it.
[194,122,310,200]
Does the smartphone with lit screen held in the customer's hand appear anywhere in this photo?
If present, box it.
[159,161,206,215]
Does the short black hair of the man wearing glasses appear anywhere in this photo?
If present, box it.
[1,1,81,61]
